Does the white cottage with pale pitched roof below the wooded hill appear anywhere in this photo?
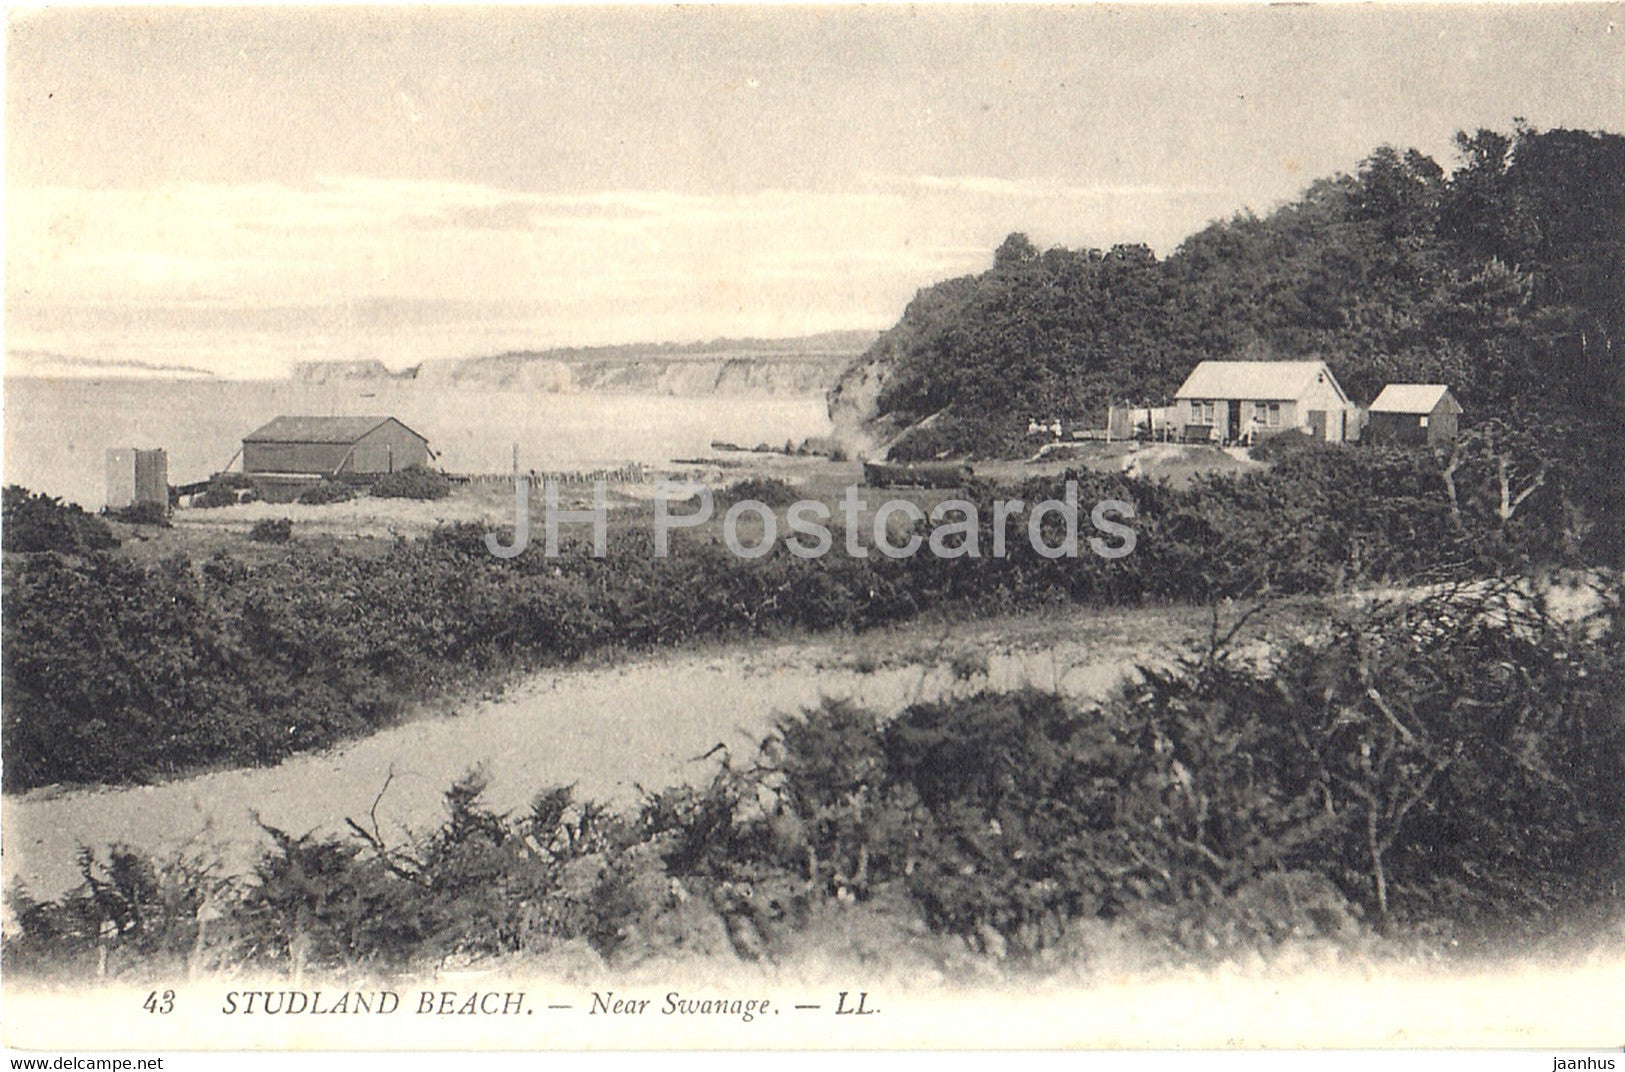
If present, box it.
[1173,361,1360,443]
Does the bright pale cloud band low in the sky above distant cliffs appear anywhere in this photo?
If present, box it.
[7,168,1248,376]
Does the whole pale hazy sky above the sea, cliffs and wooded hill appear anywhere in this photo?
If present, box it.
[5,5,1625,375]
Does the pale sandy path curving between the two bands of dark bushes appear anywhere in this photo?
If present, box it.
[0,611,1183,897]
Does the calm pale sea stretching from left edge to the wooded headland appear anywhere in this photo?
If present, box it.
[0,377,830,510]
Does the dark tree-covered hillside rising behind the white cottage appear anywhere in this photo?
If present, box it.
[868,127,1625,456]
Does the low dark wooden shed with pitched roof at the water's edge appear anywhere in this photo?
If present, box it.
[242,417,429,479]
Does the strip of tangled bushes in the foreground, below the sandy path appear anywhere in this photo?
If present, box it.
[5,583,1625,978]
